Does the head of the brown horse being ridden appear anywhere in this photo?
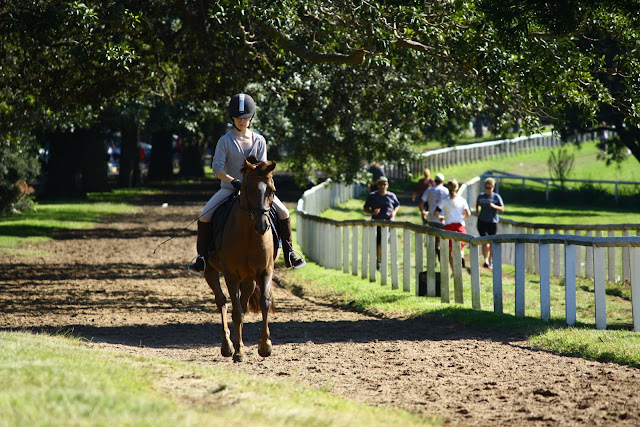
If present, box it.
[240,156,276,234]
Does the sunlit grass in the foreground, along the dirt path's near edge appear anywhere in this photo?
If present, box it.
[0,332,439,426]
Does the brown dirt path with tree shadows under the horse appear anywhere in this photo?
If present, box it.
[0,177,640,426]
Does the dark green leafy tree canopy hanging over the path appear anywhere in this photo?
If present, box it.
[0,0,640,201]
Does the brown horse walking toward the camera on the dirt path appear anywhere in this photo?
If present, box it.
[204,156,276,362]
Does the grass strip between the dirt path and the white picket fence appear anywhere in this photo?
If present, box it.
[283,254,640,367]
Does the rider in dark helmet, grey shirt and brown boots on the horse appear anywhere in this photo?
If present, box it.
[188,93,306,273]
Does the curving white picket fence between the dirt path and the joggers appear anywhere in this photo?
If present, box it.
[296,135,640,331]
